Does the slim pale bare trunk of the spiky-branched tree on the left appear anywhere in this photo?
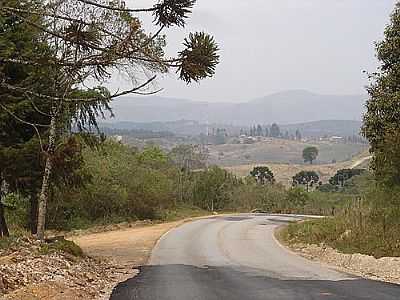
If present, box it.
[37,114,57,241]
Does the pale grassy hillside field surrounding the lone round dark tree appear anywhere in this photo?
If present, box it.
[209,138,368,167]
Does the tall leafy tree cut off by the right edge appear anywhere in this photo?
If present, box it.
[362,3,400,185]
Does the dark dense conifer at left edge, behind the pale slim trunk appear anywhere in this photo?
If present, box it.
[0,0,50,236]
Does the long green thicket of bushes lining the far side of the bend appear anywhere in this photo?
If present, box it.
[3,138,350,231]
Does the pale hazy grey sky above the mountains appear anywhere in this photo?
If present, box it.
[121,0,396,102]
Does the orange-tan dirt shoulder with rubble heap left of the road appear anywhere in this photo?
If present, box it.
[0,218,216,300]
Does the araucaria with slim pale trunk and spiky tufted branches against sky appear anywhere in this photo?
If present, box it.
[0,0,219,240]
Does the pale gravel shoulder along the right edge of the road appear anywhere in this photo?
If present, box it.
[275,226,400,284]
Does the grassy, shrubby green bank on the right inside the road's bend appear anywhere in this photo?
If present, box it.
[286,186,400,258]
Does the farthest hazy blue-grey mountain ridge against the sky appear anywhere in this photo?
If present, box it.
[108,90,367,125]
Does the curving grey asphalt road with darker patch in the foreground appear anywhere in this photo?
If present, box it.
[111,215,400,300]
